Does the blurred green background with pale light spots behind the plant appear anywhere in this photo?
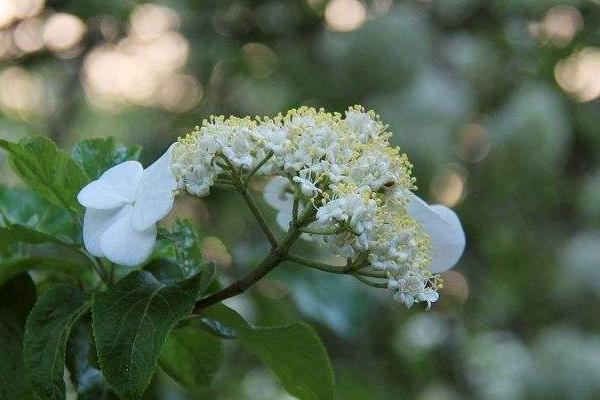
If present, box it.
[0,0,600,400]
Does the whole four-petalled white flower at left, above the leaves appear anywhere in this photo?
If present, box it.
[77,146,177,266]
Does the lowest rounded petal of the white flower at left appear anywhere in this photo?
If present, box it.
[100,206,156,266]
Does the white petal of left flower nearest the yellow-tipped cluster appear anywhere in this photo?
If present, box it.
[131,144,177,231]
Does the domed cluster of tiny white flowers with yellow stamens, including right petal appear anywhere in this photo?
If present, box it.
[172,106,464,307]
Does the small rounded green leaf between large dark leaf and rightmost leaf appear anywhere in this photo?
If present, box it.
[160,322,223,390]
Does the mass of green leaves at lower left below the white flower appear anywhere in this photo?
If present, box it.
[0,138,333,400]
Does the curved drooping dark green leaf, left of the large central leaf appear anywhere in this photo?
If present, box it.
[23,284,90,400]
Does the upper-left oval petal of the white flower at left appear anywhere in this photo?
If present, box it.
[77,161,144,210]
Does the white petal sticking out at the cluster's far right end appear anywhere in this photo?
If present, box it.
[408,195,465,272]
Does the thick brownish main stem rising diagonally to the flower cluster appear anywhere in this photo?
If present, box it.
[193,208,316,314]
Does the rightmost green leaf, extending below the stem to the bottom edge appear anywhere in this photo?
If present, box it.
[202,304,334,400]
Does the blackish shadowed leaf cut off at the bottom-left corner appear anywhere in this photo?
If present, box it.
[0,274,36,400]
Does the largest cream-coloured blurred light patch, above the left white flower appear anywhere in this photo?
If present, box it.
[83,4,203,113]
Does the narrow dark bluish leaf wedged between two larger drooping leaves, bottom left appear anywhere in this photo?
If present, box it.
[66,321,118,400]
